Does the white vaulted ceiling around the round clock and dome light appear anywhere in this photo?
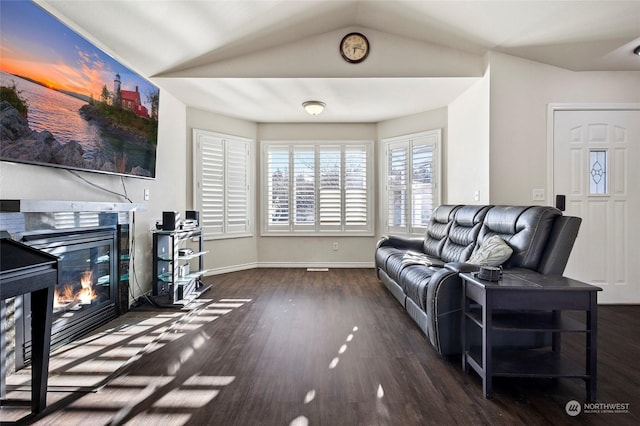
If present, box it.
[37,0,640,123]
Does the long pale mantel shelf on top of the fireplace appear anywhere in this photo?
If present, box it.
[0,200,147,213]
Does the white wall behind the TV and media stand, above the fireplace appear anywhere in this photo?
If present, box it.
[0,91,186,297]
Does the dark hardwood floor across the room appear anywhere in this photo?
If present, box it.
[0,269,640,425]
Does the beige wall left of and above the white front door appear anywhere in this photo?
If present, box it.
[490,53,640,204]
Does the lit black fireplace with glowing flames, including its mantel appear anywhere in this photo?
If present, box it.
[0,200,135,370]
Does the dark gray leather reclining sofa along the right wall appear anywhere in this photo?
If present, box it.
[375,205,581,355]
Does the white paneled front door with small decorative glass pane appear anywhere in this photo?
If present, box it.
[550,105,640,303]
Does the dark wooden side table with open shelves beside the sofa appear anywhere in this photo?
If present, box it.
[460,273,601,401]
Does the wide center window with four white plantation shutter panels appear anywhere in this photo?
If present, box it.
[262,141,373,235]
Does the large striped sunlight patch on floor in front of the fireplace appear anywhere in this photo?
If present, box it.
[7,299,251,425]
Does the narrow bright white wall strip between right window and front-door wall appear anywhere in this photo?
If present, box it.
[443,70,491,204]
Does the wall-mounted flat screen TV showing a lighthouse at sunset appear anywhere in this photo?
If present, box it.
[0,1,159,178]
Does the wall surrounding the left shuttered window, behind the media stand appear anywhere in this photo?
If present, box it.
[185,108,259,274]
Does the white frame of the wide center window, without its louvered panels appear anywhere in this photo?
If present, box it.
[260,140,375,236]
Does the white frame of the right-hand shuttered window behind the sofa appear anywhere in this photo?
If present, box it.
[379,129,442,235]
